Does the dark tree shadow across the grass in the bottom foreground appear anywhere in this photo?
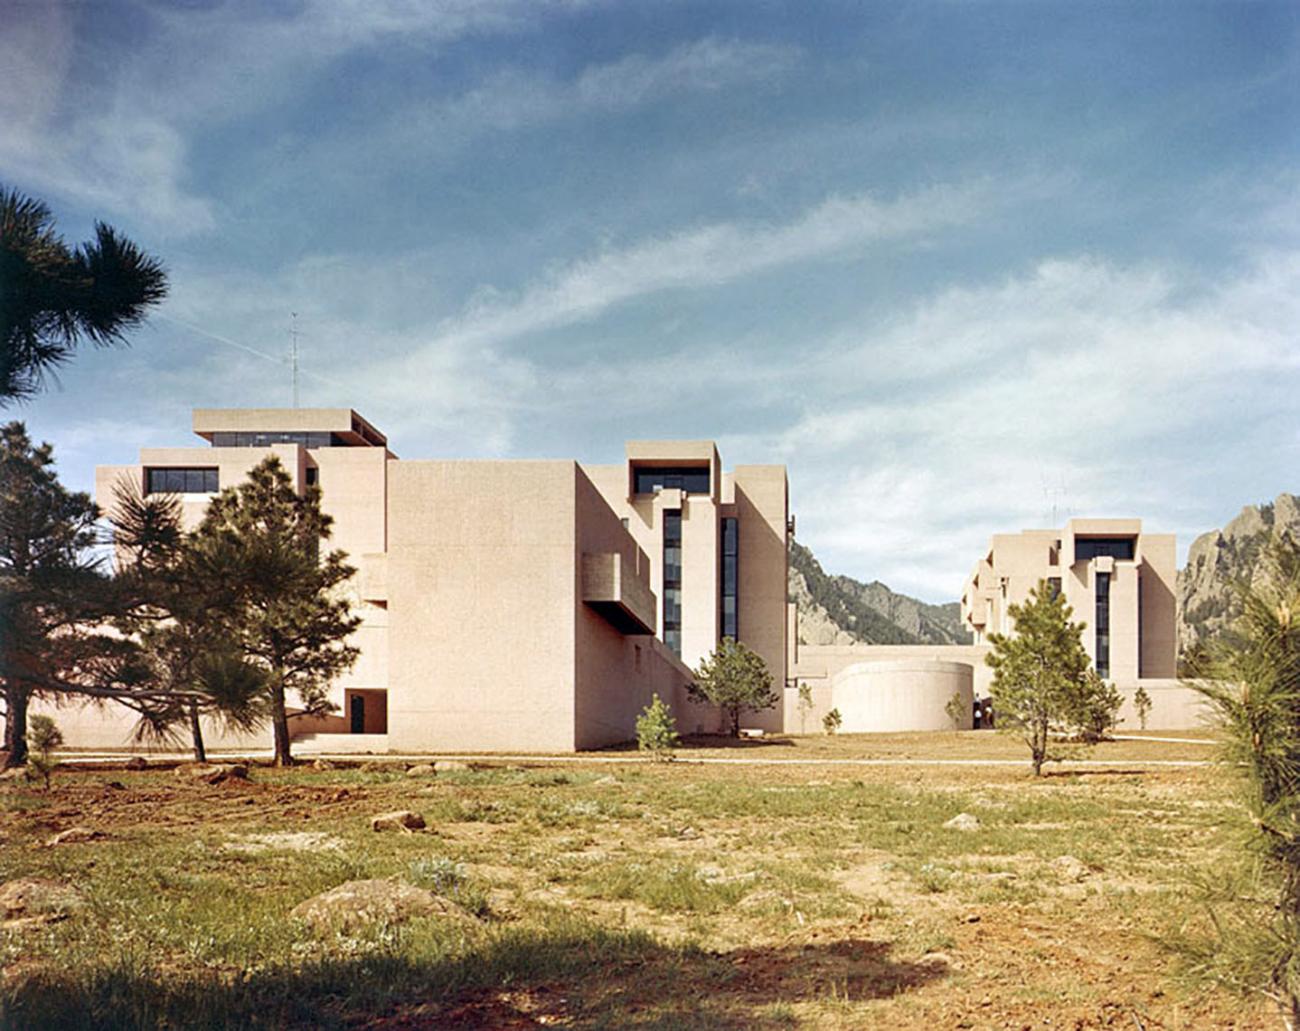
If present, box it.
[0,926,945,1031]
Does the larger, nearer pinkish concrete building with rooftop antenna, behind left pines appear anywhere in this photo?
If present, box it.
[50,408,788,751]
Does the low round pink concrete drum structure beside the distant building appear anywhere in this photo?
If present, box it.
[831,659,975,733]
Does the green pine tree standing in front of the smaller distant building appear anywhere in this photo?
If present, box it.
[987,580,1089,776]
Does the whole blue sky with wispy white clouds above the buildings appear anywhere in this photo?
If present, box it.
[0,0,1300,602]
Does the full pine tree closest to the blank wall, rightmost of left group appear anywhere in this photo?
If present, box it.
[194,456,360,766]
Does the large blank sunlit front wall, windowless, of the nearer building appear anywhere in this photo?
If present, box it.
[387,462,579,751]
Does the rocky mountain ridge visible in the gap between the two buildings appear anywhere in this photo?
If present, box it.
[789,543,971,645]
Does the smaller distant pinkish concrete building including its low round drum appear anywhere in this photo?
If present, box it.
[784,519,1201,732]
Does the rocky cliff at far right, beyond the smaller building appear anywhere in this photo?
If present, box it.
[1178,494,1300,657]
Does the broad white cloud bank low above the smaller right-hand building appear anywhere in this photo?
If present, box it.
[759,252,1300,599]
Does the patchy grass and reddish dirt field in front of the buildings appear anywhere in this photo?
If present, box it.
[0,733,1275,1030]
